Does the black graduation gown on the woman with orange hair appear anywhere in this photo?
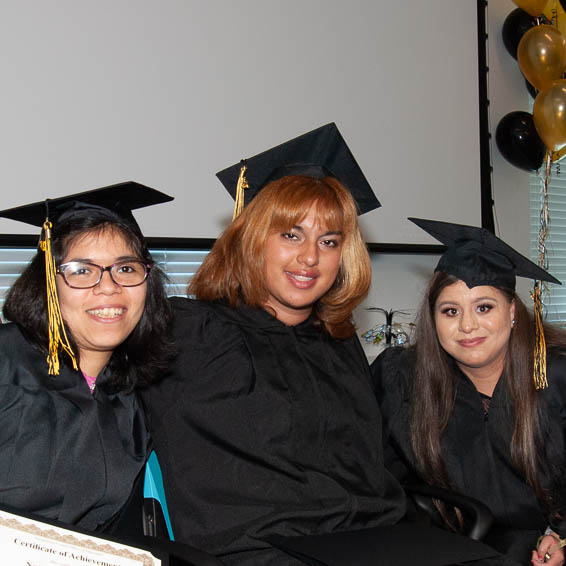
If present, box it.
[142,298,405,565]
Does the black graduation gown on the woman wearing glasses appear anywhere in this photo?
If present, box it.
[0,324,148,530]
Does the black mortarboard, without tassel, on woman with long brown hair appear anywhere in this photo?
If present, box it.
[409,218,561,289]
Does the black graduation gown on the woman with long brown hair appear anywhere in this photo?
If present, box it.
[371,348,566,563]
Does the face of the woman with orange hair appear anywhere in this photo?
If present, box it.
[264,204,343,326]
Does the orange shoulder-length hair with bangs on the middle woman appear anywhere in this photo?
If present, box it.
[188,175,371,338]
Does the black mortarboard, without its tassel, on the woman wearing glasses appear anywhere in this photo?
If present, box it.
[0,181,173,227]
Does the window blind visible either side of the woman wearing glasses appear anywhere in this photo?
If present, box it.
[0,247,208,322]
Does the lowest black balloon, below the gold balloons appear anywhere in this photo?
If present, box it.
[495,111,546,171]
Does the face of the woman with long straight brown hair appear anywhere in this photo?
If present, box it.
[434,281,515,380]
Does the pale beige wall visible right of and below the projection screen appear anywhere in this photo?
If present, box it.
[356,0,530,359]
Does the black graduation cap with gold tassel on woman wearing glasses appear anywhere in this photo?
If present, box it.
[0,181,173,375]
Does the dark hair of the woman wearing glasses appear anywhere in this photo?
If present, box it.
[3,207,174,390]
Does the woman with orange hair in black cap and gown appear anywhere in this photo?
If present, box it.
[144,124,506,566]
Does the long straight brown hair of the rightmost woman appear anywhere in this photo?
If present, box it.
[410,272,566,520]
